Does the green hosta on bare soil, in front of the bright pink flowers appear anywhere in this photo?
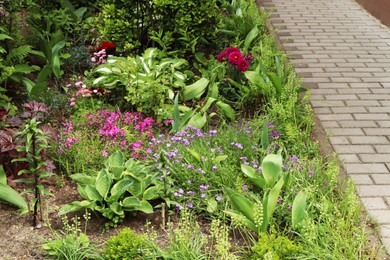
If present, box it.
[59,151,163,227]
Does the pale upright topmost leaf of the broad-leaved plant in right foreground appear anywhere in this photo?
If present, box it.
[261,154,283,188]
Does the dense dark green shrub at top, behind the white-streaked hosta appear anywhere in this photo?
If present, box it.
[90,0,220,53]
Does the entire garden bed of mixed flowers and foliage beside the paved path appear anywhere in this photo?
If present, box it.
[0,0,386,259]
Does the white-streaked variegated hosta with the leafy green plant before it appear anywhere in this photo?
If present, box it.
[93,48,192,119]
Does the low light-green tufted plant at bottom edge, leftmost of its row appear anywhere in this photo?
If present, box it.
[42,214,102,260]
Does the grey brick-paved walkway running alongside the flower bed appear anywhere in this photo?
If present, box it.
[263,0,390,252]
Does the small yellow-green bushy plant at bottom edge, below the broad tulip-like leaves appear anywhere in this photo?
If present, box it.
[251,229,303,260]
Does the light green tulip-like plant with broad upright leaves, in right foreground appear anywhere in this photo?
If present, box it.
[225,154,306,233]
